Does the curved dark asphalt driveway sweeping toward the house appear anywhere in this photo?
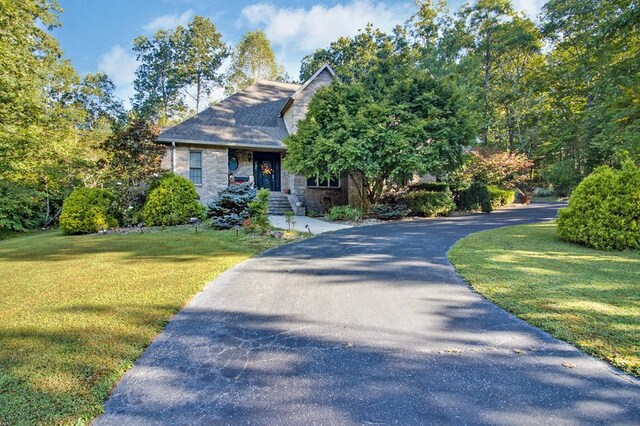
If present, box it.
[95,204,640,425]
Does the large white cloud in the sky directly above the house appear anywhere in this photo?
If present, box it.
[240,0,415,78]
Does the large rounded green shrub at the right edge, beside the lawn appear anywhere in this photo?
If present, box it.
[557,162,640,250]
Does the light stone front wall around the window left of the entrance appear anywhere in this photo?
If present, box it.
[161,144,229,205]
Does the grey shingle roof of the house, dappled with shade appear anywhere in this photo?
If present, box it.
[157,80,300,149]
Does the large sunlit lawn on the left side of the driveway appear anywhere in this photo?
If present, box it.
[0,229,288,425]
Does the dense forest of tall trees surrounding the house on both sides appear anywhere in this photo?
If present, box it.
[0,0,640,231]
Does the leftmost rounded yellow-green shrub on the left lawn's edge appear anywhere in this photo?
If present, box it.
[60,188,118,234]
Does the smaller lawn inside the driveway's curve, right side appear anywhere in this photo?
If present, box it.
[449,223,640,376]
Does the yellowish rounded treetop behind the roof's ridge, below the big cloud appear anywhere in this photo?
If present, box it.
[225,30,287,95]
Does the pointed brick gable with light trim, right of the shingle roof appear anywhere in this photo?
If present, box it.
[280,64,336,135]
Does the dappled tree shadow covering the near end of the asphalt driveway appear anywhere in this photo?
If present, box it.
[95,306,640,425]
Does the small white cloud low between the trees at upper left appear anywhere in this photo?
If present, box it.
[98,45,138,108]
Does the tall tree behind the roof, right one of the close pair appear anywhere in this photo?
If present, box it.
[175,16,229,112]
